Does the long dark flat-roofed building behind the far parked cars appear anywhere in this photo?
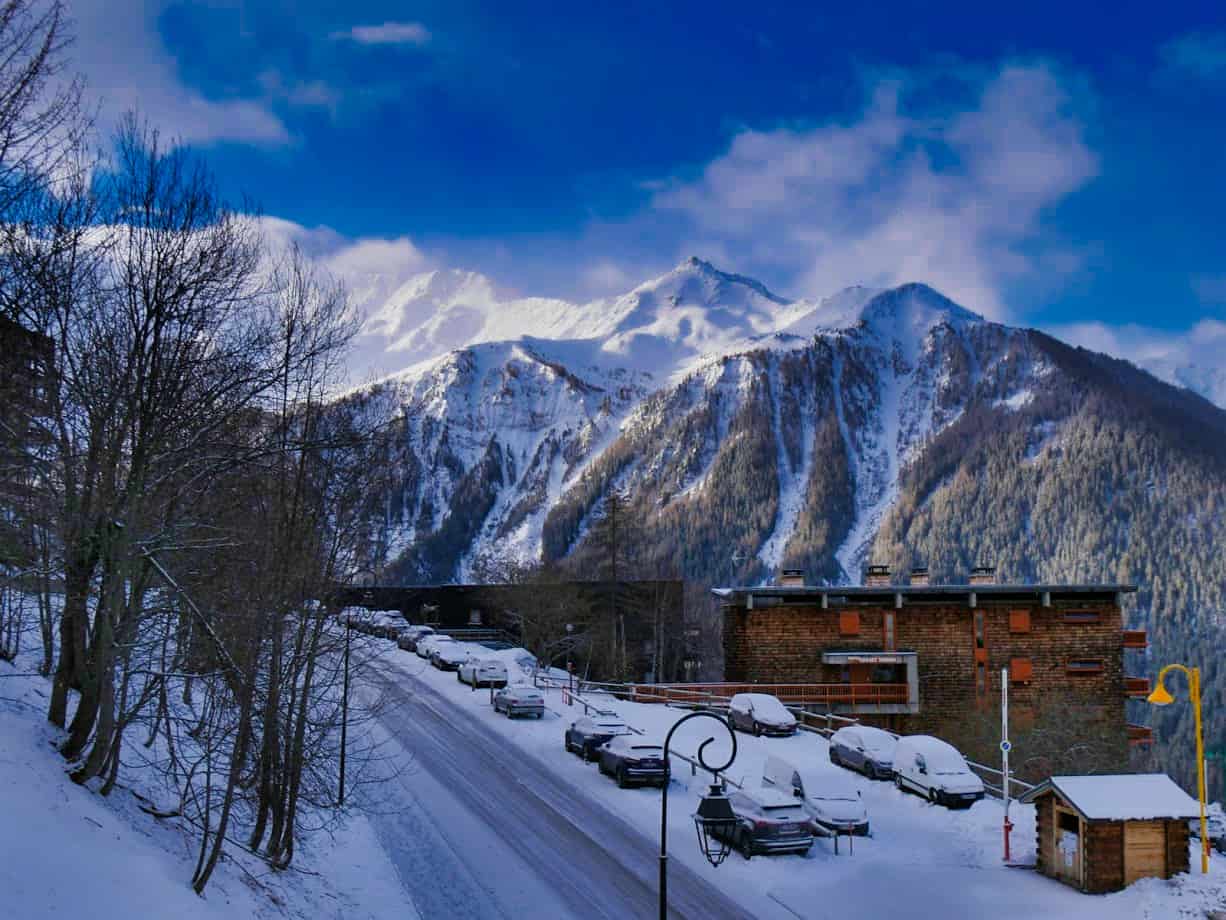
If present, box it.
[335,580,696,681]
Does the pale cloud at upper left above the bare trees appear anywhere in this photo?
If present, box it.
[69,0,289,145]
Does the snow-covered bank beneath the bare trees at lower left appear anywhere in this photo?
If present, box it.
[0,654,417,920]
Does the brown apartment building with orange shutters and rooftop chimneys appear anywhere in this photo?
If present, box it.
[715,567,1149,767]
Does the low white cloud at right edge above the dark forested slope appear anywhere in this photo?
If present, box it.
[1047,319,1226,408]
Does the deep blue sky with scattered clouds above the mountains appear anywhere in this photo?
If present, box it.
[70,0,1226,368]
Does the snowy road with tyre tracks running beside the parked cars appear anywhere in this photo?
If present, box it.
[362,667,749,920]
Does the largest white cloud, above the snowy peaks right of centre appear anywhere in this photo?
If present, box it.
[653,65,1097,318]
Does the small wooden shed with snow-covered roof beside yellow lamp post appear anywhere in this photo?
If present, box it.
[1021,773,1200,894]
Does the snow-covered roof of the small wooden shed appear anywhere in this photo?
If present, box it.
[1020,773,1200,821]
